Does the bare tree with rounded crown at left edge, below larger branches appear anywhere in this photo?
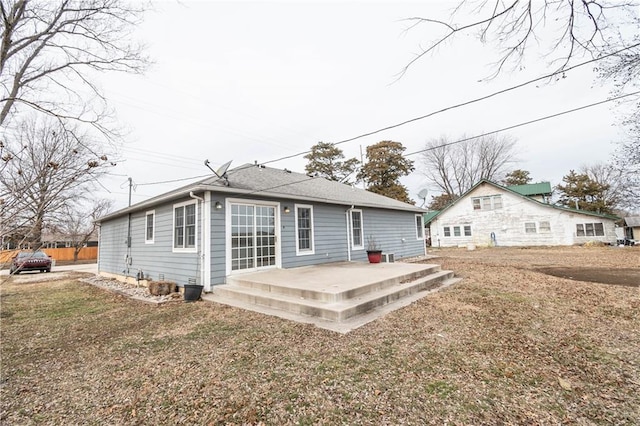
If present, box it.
[0,119,115,245]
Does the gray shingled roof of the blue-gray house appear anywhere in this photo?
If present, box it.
[99,164,425,222]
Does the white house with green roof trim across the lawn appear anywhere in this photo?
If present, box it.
[430,180,618,247]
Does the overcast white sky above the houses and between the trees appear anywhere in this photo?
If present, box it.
[101,1,623,208]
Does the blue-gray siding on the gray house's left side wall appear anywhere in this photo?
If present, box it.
[99,198,202,286]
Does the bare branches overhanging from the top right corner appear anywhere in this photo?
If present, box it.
[401,0,640,165]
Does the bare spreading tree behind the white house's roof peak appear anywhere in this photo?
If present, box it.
[420,134,516,197]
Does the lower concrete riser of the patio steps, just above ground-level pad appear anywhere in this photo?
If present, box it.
[216,271,454,321]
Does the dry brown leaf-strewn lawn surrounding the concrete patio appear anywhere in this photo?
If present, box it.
[0,247,640,425]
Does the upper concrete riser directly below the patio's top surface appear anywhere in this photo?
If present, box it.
[227,265,440,302]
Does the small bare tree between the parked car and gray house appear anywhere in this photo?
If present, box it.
[52,199,113,262]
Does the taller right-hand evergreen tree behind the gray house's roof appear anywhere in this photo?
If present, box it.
[358,141,414,204]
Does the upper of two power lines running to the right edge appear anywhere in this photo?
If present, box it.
[262,43,640,164]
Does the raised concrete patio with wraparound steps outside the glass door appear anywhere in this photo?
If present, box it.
[202,262,459,333]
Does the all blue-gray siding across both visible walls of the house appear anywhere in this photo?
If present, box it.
[99,192,424,285]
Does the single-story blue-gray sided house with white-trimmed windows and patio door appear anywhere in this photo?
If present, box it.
[98,164,425,291]
